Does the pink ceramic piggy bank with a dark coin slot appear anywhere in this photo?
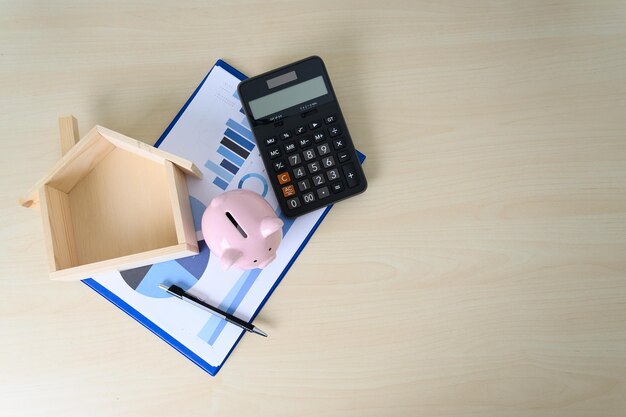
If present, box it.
[202,190,283,269]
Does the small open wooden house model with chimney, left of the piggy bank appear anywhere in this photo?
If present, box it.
[21,117,201,280]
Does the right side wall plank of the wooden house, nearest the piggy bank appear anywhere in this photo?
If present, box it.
[165,161,198,247]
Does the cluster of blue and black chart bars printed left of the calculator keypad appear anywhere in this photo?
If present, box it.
[204,119,256,190]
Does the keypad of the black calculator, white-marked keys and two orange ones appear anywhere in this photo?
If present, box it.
[265,114,361,216]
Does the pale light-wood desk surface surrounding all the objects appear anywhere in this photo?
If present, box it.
[0,0,626,417]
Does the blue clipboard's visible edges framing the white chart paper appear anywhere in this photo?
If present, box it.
[83,59,365,376]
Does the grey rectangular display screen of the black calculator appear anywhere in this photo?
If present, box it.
[249,75,328,120]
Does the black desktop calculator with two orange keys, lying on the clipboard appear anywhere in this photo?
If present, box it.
[238,56,367,217]
